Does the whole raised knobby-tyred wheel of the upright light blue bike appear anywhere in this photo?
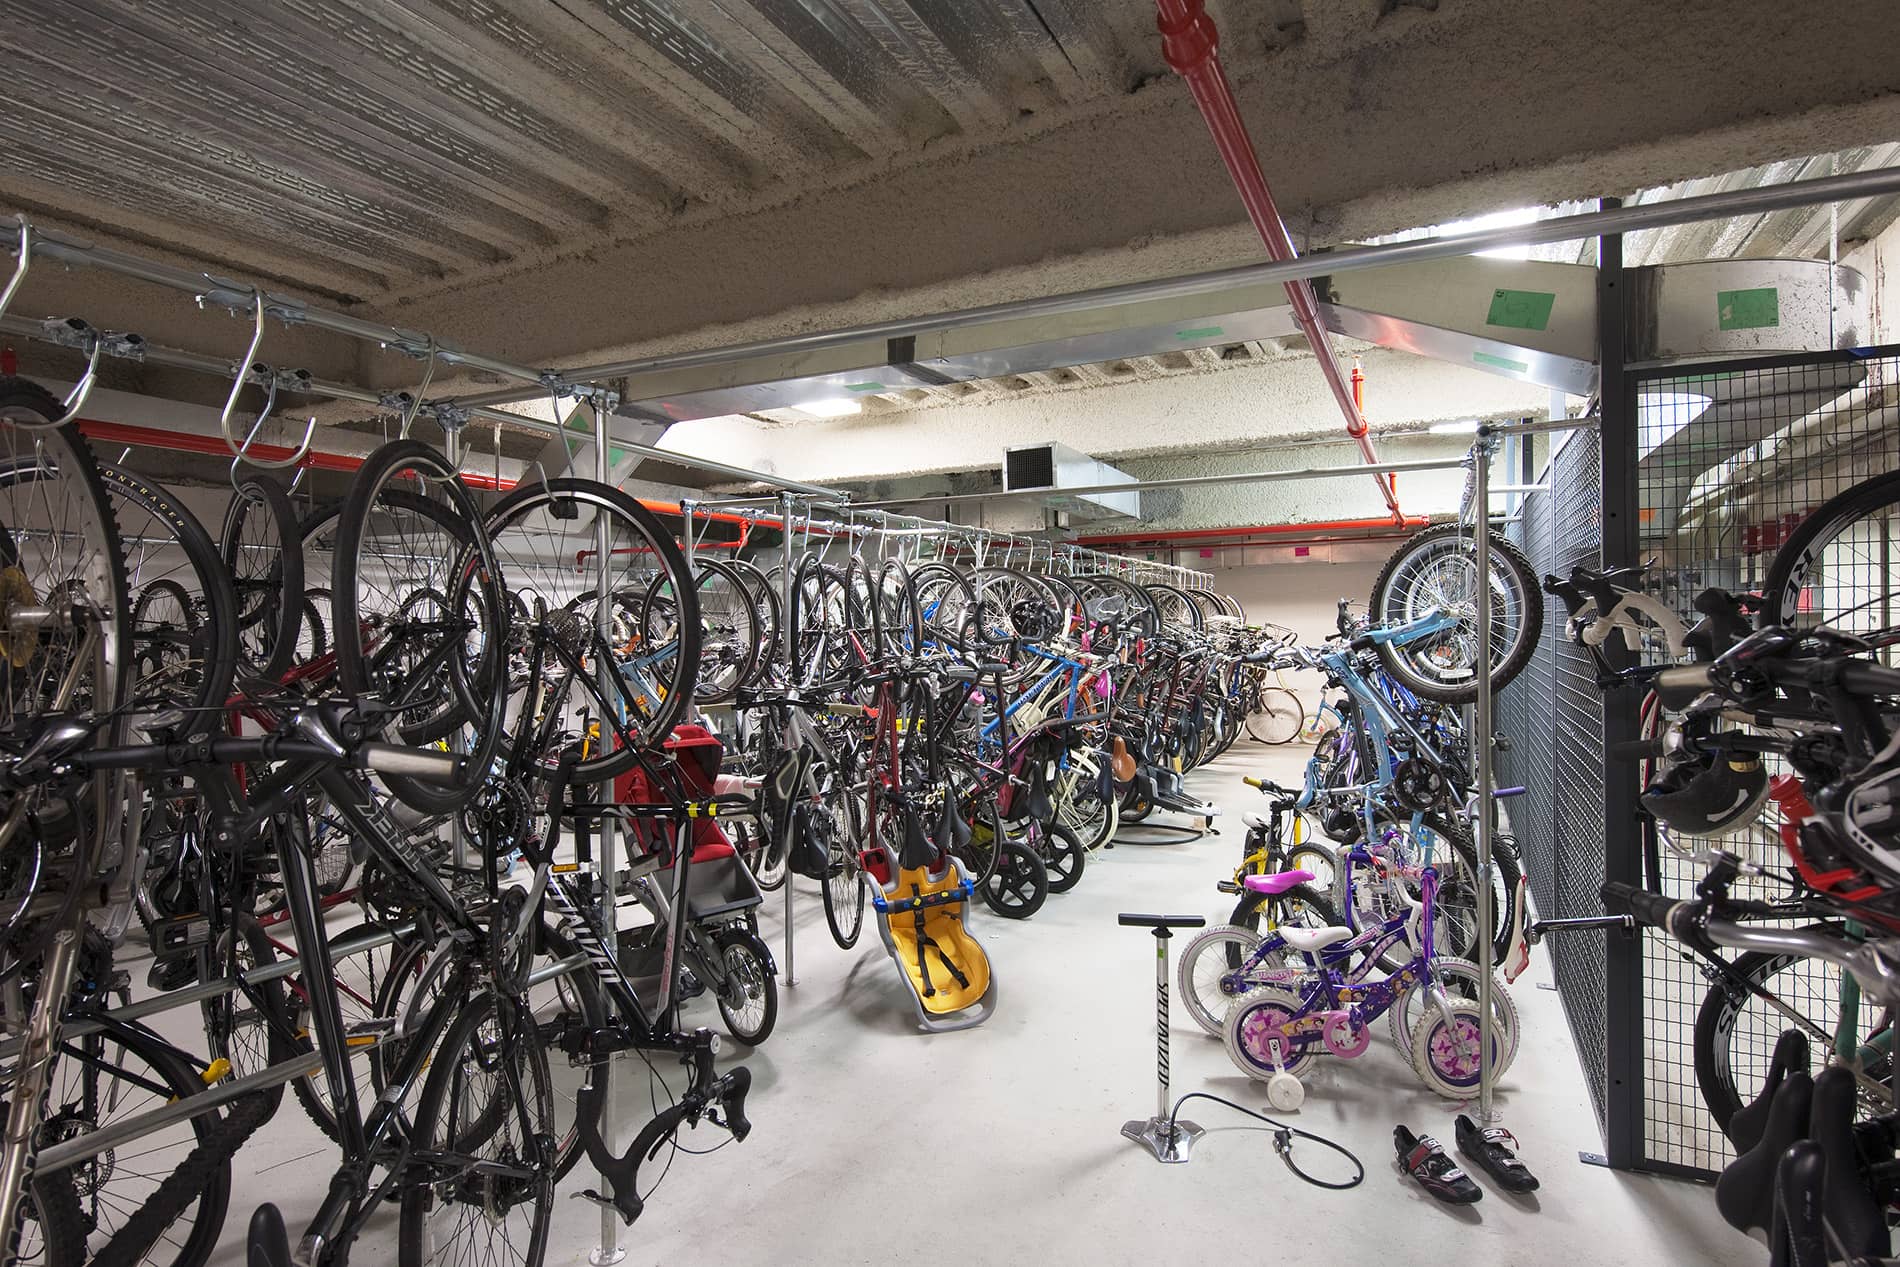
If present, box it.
[1368,524,1543,705]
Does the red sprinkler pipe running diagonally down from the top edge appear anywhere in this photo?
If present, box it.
[1155,0,1404,524]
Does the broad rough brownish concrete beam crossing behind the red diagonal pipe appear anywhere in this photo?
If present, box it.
[326,0,1900,387]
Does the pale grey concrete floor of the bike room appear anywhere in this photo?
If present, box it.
[200,747,1765,1267]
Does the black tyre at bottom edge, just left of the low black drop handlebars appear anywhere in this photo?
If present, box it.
[397,993,555,1267]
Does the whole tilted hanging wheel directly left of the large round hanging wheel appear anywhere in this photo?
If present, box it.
[334,441,509,813]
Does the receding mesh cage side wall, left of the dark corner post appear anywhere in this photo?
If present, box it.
[1497,431,1609,1126]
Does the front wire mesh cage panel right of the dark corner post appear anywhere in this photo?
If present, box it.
[1619,350,1900,1172]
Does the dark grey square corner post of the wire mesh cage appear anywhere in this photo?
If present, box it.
[1588,198,1645,1166]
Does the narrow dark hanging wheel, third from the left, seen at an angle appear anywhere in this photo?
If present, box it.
[219,475,304,680]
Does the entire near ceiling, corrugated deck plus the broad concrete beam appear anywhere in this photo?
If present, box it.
[11,0,1900,416]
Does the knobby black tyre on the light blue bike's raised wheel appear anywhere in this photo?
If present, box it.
[1368,524,1543,705]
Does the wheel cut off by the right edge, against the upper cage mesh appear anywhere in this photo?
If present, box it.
[1759,471,1900,633]
